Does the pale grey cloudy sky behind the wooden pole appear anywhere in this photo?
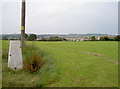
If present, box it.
[0,0,118,34]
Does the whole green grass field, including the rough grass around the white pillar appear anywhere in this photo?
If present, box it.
[2,41,118,87]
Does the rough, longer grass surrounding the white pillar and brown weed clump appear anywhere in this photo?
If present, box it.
[2,41,58,87]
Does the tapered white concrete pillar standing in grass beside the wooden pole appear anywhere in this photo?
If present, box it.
[8,41,23,70]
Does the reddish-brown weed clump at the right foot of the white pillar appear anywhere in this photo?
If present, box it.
[24,55,44,72]
